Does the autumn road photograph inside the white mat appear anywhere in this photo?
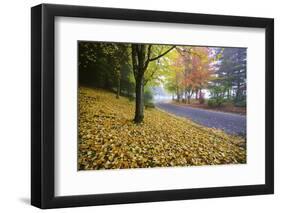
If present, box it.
[77,41,247,171]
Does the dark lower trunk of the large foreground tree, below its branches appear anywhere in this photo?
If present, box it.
[134,78,144,123]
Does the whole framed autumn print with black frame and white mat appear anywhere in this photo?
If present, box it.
[31,4,274,208]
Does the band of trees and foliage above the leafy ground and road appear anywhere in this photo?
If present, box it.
[79,42,246,122]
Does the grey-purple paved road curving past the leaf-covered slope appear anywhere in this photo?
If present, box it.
[156,102,246,135]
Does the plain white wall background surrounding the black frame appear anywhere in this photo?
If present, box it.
[0,0,276,213]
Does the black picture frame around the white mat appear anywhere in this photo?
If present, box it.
[31,4,274,209]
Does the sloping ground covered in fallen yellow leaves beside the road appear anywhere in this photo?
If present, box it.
[78,87,246,170]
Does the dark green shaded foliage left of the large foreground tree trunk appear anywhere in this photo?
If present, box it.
[78,41,132,96]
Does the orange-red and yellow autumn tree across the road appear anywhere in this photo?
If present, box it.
[164,46,212,103]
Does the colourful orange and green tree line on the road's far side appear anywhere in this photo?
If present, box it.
[163,46,247,106]
